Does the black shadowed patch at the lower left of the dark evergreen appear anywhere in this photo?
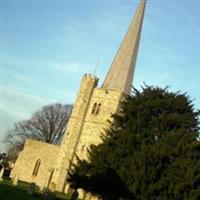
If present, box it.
[70,168,134,200]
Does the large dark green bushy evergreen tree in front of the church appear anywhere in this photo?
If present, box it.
[68,86,200,200]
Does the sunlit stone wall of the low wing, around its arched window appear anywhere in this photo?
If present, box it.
[11,139,59,188]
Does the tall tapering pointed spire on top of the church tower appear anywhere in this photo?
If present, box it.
[102,0,146,94]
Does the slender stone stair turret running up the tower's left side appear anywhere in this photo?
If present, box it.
[53,74,98,191]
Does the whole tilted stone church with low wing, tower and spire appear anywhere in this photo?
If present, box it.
[11,0,146,198]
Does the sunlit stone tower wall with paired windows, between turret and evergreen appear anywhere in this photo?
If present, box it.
[76,88,121,159]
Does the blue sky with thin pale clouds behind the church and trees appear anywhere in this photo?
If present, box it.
[0,0,200,149]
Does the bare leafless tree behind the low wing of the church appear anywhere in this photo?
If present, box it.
[5,103,72,160]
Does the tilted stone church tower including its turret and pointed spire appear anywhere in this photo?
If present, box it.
[51,0,146,191]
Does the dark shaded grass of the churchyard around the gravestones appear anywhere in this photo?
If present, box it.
[0,179,69,200]
